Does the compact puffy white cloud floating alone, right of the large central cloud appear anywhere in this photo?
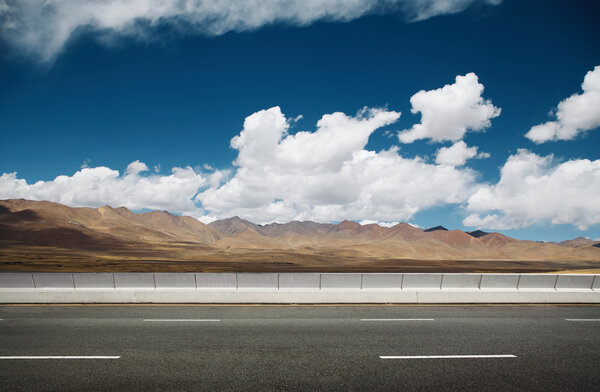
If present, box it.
[398,72,500,143]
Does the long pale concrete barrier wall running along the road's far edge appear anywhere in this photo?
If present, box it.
[0,272,600,303]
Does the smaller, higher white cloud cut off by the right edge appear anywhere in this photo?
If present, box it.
[525,65,600,143]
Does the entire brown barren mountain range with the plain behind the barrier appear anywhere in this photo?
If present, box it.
[0,199,600,271]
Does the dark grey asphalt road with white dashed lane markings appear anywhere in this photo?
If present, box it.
[0,306,600,391]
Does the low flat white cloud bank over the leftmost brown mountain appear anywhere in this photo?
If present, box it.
[0,161,207,212]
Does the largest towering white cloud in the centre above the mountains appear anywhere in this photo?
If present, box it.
[196,107,475,223]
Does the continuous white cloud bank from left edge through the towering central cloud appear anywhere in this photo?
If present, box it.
[0,107,475,225]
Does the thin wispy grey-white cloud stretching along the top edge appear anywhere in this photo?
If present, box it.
[0,0,501,61]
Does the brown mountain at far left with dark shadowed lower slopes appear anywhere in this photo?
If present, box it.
[0,199,221,246]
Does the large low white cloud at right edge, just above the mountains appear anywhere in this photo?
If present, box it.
[463,149,600,230]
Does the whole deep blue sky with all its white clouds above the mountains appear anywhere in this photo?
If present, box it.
[0,0,600,241]
